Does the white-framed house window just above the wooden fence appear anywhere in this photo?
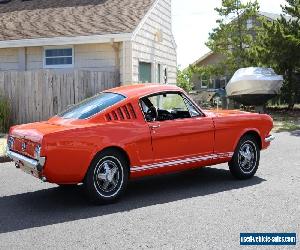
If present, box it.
[44,47,74,68]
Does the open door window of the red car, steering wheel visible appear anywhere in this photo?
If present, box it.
[141,93,192,122]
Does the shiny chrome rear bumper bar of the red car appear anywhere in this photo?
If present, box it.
[7,150,46,172]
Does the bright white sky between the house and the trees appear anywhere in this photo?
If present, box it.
[172,0,285,69]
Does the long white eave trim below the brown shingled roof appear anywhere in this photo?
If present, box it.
[0,33,132,49]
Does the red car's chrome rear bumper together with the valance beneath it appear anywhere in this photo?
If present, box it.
[6,150,46,177]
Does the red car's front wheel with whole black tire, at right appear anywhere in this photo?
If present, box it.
[228,135,260,179]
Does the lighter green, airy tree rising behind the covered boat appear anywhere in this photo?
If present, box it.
[206,0,259,74]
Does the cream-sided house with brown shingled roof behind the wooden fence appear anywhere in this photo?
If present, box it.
[0,0,177,84]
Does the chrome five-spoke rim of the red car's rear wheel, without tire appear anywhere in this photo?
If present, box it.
[93,156,123,197]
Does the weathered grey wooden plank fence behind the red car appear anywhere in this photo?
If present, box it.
[0,70,120,124]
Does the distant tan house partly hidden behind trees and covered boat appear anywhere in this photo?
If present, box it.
[192,12,291,91]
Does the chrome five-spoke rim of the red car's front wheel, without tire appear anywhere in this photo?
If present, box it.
[238,141,257,173]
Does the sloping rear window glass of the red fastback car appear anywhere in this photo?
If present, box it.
[58,92,125,119]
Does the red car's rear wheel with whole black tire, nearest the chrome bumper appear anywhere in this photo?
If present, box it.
[84,149,129,204]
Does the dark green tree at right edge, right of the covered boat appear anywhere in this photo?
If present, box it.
[252,0,300,109]
